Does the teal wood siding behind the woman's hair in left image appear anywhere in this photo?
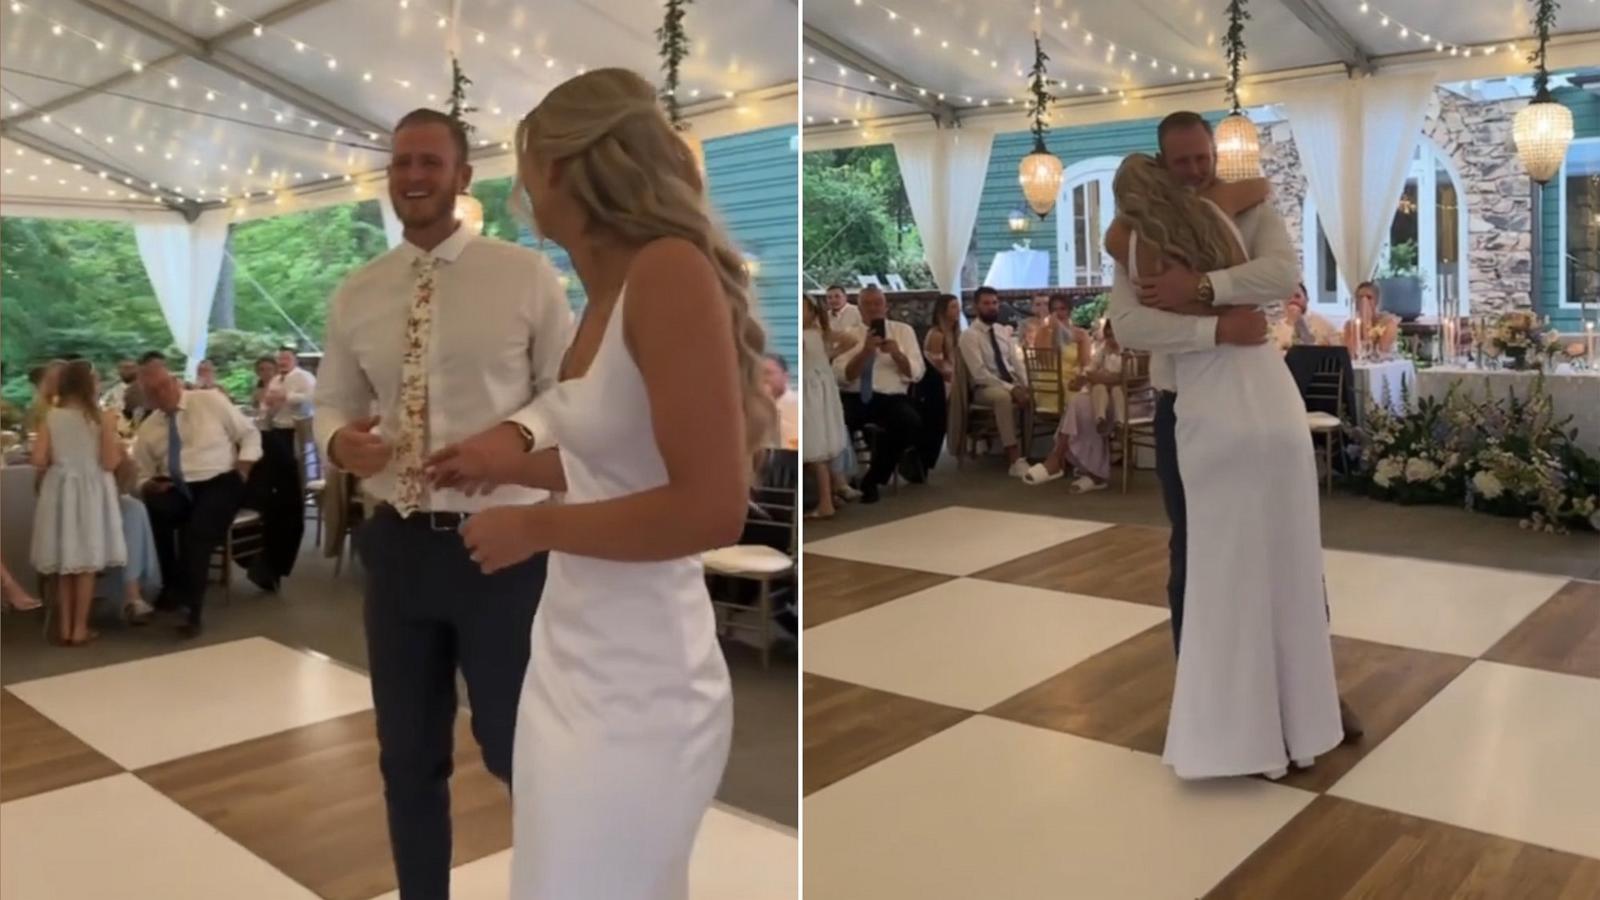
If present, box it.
[522,125,800,373]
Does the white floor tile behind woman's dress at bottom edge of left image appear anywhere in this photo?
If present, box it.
[360,809,800,900]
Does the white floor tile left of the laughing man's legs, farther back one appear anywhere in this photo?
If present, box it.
[10,637,373,769]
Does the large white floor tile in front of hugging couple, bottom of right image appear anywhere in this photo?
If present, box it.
[805,717,1312,900]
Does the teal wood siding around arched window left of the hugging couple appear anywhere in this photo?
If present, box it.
[974,112,1222,285]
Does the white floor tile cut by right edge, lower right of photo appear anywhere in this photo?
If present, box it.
[1330,661,1600,858]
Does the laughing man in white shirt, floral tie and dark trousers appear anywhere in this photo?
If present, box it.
[315,109,573,900]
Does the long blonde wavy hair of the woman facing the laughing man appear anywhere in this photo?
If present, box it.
[517,69,778,458]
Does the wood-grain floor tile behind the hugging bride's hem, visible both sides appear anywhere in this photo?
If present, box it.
[987,625,1470,793]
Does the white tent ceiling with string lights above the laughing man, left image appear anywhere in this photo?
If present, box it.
[0,0,797,216]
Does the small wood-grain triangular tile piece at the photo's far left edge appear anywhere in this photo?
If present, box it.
[0,690,122,802]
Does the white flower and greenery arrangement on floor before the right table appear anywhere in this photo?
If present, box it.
[1354,378,1600,533]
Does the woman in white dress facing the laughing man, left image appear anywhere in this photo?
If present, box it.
[434,69,776,900]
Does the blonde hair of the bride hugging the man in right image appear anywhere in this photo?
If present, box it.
[1110,154,1243,272]
